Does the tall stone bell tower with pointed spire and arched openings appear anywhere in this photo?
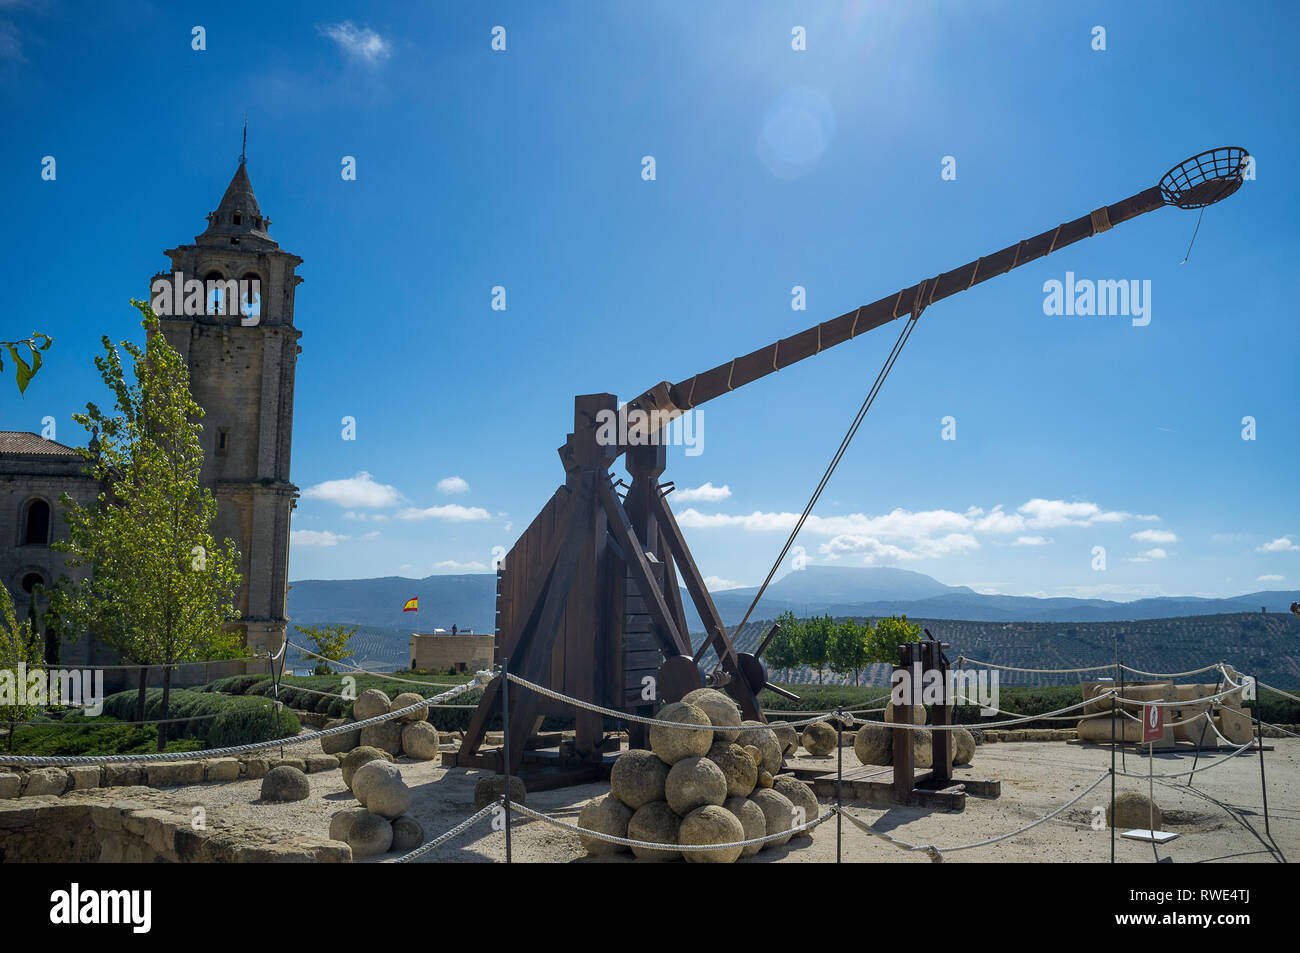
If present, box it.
[155,156,303,653]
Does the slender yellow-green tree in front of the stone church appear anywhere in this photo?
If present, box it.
[56,300,239,751]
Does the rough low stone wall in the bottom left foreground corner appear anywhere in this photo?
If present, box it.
[0,788,352,863]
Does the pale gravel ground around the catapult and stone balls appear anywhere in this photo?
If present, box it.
[147,738,1300,863]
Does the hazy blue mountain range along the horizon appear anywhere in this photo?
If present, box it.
[289,566,1300,632]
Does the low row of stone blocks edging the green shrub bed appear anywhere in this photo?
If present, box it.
[0,754,341,798]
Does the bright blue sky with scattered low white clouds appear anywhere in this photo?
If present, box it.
[0,0,1300,599]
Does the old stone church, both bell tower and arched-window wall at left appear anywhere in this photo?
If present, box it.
[0,157,303,662]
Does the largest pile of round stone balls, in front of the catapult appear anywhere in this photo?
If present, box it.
[579,688,835,863]
